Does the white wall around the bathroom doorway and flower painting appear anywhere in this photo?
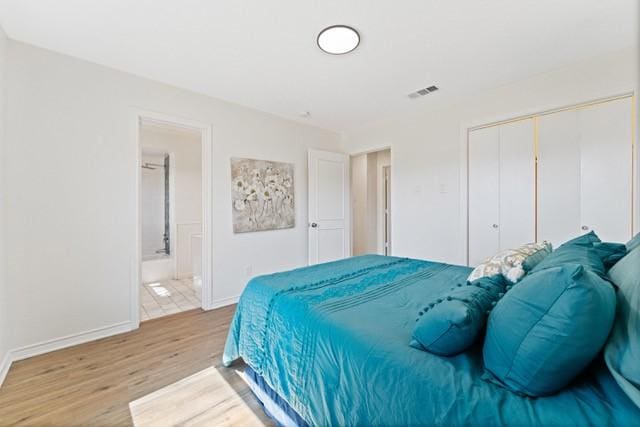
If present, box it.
[5,41,339,349]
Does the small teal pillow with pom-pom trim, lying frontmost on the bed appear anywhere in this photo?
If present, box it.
[409,275,506,356]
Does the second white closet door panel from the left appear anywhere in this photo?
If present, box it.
[499,119,535,250]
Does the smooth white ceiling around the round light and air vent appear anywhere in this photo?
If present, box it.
[0,0,638,131]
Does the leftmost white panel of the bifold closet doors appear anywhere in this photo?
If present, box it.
[469,127,500,266]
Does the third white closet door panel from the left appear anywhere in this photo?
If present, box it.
[538,110,580,247]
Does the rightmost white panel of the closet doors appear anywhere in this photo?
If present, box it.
[578,98,632,242]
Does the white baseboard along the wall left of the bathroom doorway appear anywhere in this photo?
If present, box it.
[10,321,133,362]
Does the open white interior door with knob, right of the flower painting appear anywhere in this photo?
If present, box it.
[309,150,351,265]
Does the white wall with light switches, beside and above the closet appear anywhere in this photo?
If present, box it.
[343,47,640,264]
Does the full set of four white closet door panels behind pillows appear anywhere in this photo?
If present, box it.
[467,96,634,265]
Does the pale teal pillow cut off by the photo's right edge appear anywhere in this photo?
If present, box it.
[604,247,640,407]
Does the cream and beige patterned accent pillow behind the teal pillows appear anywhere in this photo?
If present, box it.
[467,240,552,283]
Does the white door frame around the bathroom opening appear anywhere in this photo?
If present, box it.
[129,108,213,329]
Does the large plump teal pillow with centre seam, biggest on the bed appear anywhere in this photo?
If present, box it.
[483,264,616,396]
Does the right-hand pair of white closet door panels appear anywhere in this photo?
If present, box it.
[538,98,633,246]
